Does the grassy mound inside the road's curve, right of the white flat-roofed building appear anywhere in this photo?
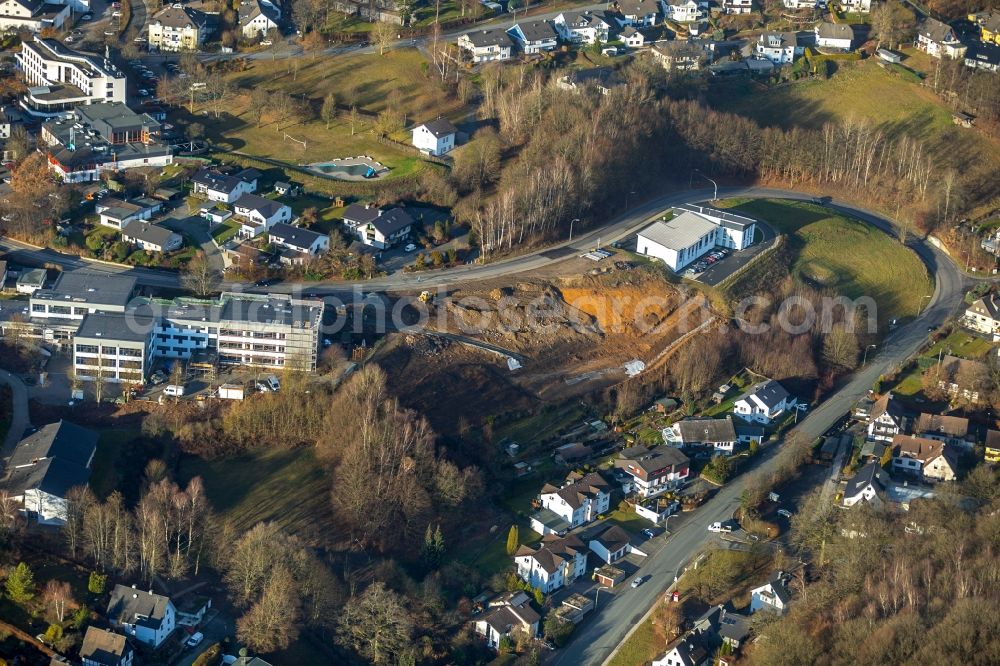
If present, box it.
[735,199,934,324]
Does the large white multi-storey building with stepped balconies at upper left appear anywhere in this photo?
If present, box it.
[15,35,125,118]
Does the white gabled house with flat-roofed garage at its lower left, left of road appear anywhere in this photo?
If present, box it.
[531,472,611,534]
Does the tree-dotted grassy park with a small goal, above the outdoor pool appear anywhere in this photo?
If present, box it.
[198,49,464,178]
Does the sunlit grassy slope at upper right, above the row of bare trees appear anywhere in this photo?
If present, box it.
[713,61,1000,198]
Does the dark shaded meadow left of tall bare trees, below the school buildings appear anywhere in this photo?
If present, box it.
[178,448,333,541]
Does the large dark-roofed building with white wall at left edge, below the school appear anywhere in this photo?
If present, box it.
[0,421,97,525]
